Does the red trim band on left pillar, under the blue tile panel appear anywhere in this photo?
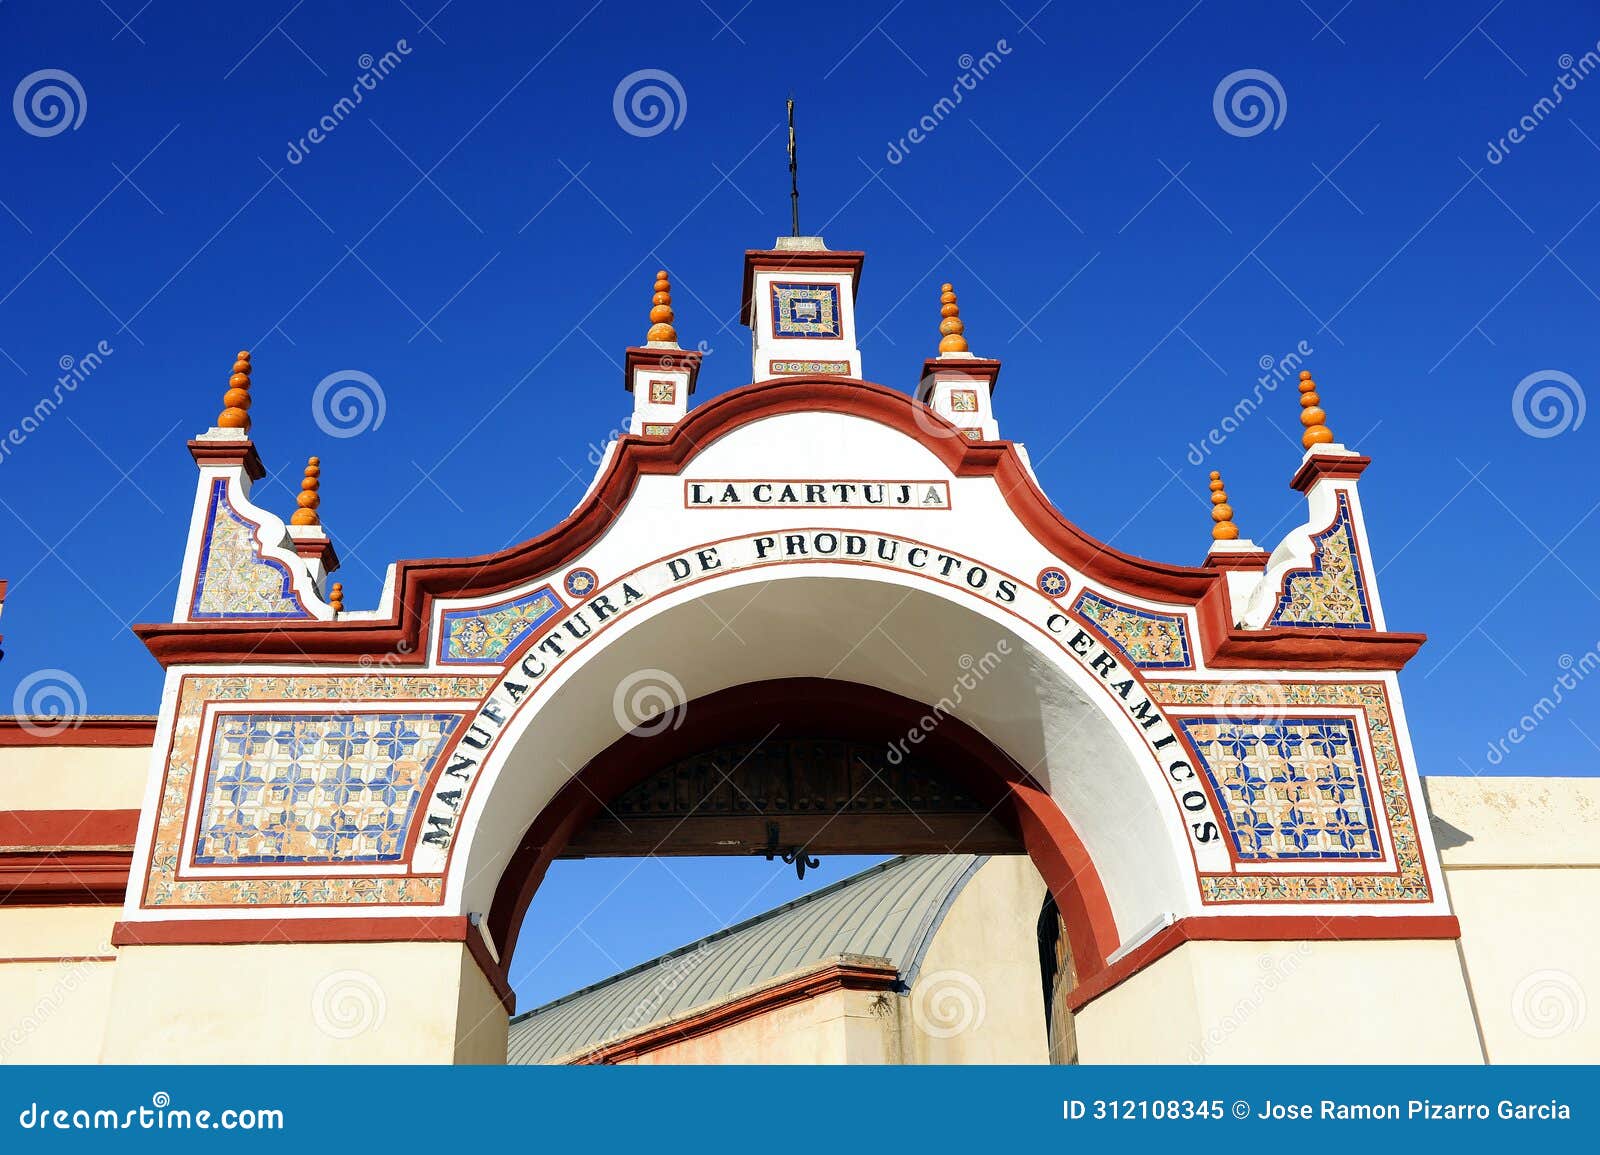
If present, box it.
[110,915,515,1014]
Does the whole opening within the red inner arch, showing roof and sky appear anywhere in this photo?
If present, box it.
[491,678,1106,1062]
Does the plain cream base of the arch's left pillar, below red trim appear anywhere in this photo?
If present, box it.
[102,942,507,1064]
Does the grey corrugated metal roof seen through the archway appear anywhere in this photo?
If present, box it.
[507,854,987,1064]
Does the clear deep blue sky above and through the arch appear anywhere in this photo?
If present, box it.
[0,0,1600,1003]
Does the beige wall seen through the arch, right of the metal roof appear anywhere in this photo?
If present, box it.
[904,854,1050,1064]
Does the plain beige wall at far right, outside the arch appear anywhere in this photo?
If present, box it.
[1426,777,1600,1062]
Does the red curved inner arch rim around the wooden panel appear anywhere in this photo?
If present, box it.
[488,678,1118,971]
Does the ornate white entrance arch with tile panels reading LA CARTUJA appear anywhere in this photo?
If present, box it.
[107,250,1456,1061]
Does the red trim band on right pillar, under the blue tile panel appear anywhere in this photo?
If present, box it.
[1067,915,1461,1013]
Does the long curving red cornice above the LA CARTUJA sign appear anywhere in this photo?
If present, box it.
[134,372,1416,669]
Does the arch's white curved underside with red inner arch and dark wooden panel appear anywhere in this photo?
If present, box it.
[453,563,1189,1055]
